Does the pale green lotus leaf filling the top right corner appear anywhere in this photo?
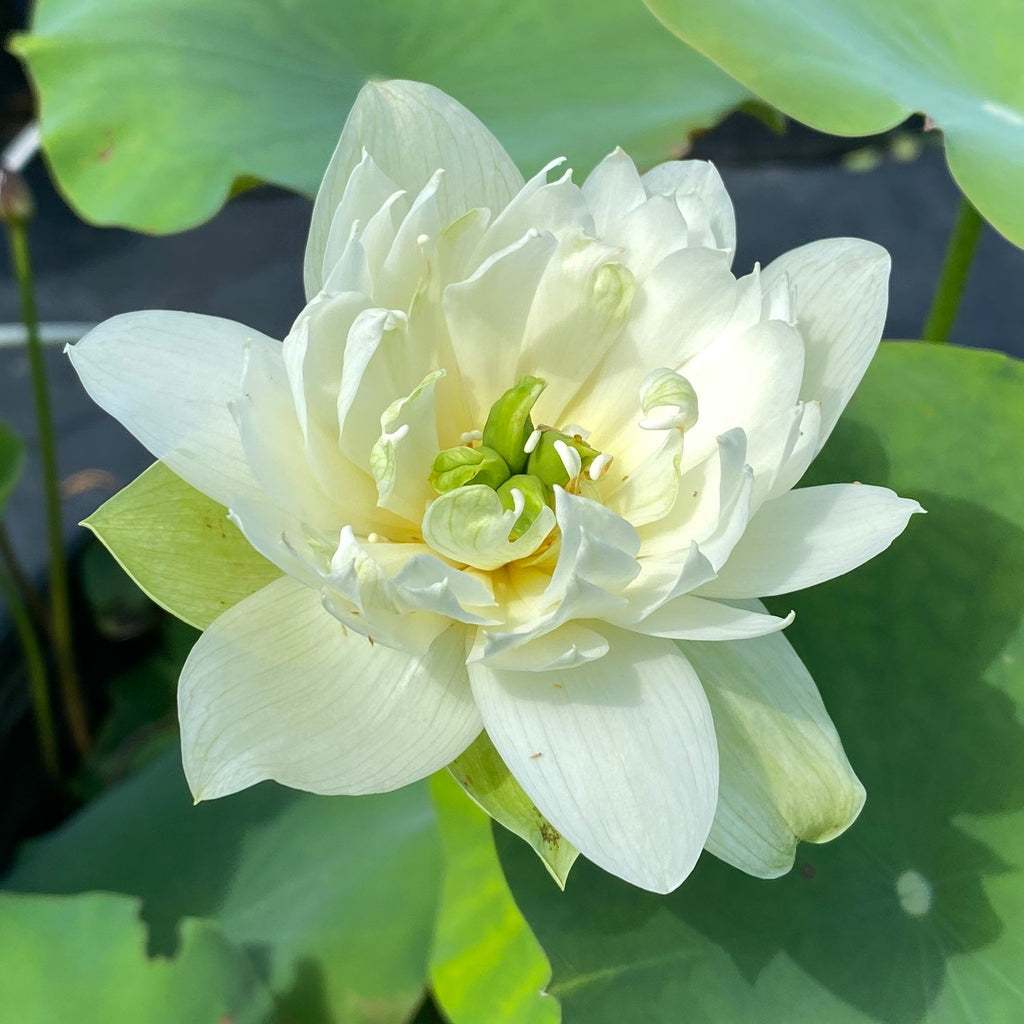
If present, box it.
[646,0,1024,245]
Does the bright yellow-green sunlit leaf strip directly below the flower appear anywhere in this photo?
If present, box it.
[430,772,561,1024]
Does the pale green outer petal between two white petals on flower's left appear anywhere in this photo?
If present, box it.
[82,462,281,630]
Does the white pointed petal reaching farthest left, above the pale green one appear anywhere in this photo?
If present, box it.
[68,310,268,505]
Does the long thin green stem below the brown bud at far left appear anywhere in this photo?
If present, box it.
[6,218,89,755]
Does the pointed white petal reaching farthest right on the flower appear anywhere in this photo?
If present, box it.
[697,483,924,598]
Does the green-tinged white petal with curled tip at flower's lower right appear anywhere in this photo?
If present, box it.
[680,634,864,878]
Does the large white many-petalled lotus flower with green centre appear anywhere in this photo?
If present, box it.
[71,82,919,892]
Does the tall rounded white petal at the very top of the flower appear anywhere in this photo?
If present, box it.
[305,80,523,297]
